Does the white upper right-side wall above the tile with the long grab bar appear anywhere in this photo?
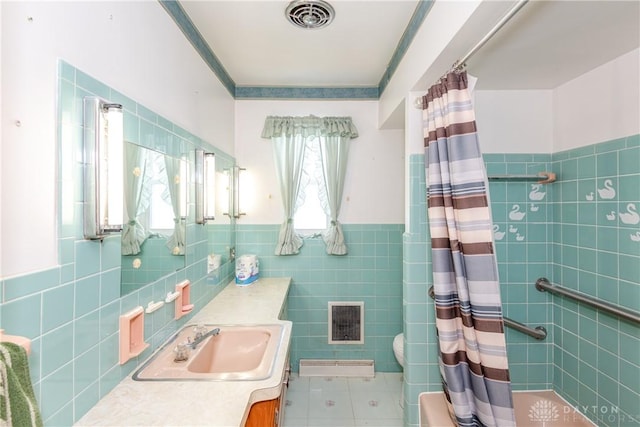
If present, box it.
[553,49,640,152]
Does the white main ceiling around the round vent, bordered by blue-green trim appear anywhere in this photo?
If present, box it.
[180,0,418,87]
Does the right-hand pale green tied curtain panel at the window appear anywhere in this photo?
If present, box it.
[319,118,358,255]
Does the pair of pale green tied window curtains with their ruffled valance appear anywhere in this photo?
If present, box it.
[262,116,358,255]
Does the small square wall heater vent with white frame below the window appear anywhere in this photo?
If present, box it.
[328,301,364,344]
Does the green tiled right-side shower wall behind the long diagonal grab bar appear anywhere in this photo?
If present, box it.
[547,135,640,426]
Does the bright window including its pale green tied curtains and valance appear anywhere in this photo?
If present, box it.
[262,116,358,255]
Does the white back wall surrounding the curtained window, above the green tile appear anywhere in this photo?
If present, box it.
[235,100,404,224]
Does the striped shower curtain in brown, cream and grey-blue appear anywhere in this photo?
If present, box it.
[422,72,515,426]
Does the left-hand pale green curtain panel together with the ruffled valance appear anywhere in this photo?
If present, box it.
[262,116,358,255]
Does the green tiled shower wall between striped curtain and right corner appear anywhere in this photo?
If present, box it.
[484,154,555,390]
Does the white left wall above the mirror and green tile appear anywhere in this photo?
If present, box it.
[0,1,234,278]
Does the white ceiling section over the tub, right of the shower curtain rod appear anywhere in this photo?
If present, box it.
[467,0,640,89]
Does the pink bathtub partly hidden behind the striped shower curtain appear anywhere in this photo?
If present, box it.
[419,390,597,427]
